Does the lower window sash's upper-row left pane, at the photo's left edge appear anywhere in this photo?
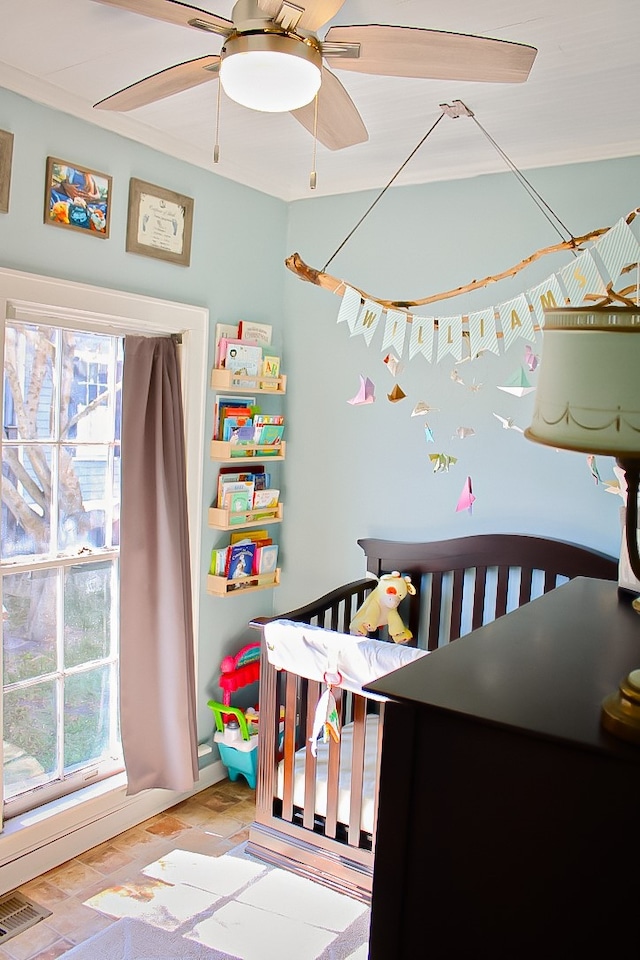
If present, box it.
[2,570,57,687]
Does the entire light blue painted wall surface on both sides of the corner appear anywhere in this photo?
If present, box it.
[0,84,640,740]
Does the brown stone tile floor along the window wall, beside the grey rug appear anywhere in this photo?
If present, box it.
[0,778,255,960]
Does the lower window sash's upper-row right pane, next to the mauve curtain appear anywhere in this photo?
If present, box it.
[64,560,113,669]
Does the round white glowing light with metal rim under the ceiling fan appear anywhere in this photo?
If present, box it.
[220,33,322,113]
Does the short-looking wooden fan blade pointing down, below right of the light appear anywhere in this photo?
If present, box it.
[291,67,369,150]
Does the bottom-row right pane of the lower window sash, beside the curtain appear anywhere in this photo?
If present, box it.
[64,666,117,773]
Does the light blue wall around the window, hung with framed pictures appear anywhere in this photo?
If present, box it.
[0,89,287,740]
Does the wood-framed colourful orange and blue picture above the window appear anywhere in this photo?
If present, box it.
[44,157,112,239]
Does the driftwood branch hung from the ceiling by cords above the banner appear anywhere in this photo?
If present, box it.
[285,207,640,310]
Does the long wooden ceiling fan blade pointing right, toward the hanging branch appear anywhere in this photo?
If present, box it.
[323,24,538,83]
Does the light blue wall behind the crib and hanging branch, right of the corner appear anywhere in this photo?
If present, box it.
[278,158,640,610]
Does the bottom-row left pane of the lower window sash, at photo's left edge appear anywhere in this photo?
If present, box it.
[3,680,57,799]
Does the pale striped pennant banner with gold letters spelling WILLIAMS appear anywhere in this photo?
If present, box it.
[337,218,640,364]
